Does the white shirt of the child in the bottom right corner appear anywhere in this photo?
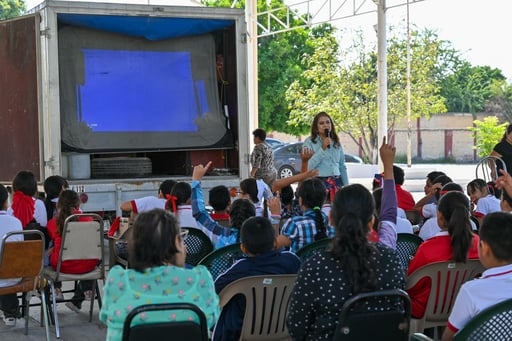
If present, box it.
[448,264,512,329]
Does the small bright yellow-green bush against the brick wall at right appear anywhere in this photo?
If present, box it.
[468,116,508,157]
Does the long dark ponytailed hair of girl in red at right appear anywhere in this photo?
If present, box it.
[437,187,473,262]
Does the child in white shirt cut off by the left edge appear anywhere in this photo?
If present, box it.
[0,184,23,326]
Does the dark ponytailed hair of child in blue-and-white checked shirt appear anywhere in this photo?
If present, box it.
[297,178,327,240]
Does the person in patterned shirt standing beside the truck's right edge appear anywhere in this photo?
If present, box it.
[250,128,277,188]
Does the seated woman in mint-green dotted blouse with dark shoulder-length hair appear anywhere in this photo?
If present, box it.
[100,209,220,341]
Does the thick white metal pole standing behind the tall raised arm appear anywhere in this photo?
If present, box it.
[376,0,388,169]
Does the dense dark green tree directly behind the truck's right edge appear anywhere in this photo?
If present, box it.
[203,0,334,135]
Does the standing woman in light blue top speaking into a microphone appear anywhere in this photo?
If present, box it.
[304,111,348,194]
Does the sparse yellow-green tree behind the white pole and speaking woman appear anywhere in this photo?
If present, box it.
[287,26,449,162]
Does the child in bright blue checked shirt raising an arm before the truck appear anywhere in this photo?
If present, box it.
[192,162,256,249]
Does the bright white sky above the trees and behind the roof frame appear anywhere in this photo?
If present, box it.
[26,0,512,82]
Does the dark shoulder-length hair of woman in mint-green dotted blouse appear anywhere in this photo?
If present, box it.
[128,208,180,272]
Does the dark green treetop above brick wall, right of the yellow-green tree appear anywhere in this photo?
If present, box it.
[441,62,505,114]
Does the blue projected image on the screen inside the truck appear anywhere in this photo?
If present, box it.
[77,49,202,132]
